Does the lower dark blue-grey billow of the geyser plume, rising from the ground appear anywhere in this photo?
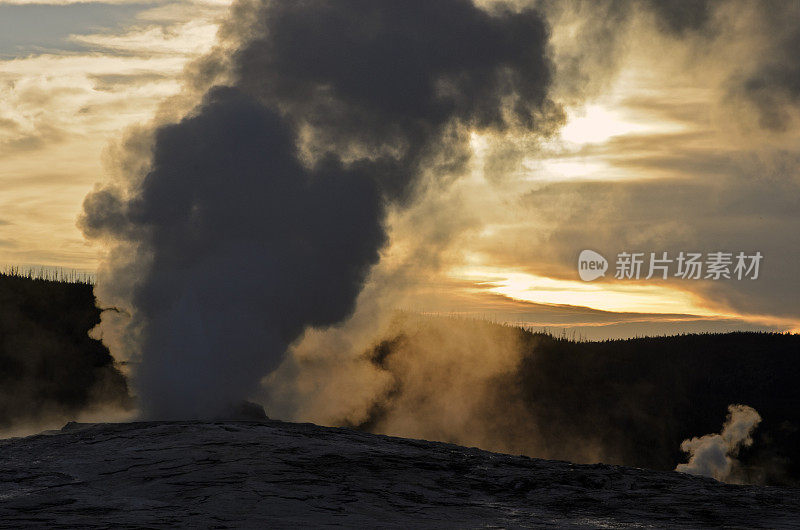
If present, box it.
[83,88,384,417]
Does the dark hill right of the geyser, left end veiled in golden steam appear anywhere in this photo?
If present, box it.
[353,318,800,485]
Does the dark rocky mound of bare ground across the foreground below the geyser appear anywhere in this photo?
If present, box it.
[0,421,800,528]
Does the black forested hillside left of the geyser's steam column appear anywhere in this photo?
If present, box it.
[0,271,131,428]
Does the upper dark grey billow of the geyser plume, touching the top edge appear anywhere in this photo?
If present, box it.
[228,0,561,196]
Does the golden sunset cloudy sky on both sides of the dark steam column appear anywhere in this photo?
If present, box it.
[0,0,800,337]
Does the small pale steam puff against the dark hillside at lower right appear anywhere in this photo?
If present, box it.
[675,405,761,482]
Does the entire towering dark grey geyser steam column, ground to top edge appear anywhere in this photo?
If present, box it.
[80,0,562,418]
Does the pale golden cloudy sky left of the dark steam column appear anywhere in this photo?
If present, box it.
[0,1,223,264]
